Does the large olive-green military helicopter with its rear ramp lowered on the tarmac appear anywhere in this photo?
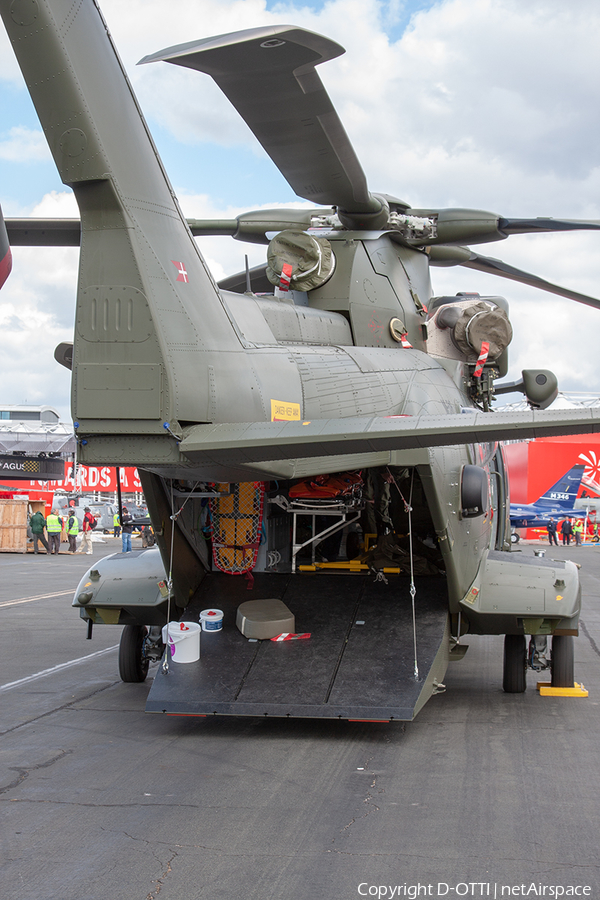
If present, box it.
[0,0,600,721]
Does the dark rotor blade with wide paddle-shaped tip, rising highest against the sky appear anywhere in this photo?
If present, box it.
[141,25,381,213]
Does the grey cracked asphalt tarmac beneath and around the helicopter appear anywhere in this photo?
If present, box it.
[0,538,600,900]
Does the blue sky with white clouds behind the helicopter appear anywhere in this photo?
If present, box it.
[0,0,600,419]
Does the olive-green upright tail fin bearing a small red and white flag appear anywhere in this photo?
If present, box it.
[0,0,240,435]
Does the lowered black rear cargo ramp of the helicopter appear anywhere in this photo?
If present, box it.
[146,574,448,720]
